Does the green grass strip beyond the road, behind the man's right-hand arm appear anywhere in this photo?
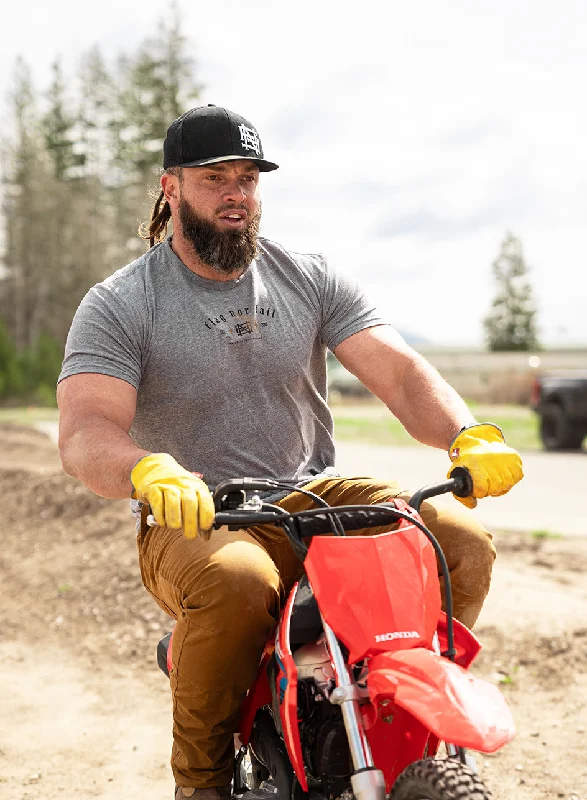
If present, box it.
[332,402,541,450]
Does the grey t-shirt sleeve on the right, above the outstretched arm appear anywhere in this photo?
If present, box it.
[321,262,390,350]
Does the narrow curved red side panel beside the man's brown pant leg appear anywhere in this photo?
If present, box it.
[275,583,308,792]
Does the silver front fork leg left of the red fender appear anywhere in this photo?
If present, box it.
[322,617,385,800]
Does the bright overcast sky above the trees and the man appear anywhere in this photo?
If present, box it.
[0,0,587,345]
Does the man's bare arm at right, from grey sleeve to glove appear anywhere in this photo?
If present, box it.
[334,325,476,450]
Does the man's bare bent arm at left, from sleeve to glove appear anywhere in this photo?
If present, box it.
[57,373,148,498]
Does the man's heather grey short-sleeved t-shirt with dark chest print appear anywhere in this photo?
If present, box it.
[59,239,385,485]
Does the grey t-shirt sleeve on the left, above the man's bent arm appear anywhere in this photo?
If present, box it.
[59,283,144,389]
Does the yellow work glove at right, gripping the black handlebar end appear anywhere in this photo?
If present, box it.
[448,422,524,508]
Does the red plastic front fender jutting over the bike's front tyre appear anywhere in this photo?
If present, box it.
[367,647,516,753]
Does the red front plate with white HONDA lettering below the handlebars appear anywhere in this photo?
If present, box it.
[304,523,440,664]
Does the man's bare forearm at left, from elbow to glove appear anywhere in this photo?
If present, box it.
[59,414,149,498]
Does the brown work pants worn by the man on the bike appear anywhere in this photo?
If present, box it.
[138,478,495,788]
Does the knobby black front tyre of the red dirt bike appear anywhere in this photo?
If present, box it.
[391,758,492,800]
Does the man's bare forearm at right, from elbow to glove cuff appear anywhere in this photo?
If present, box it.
[382,354,476,450]
